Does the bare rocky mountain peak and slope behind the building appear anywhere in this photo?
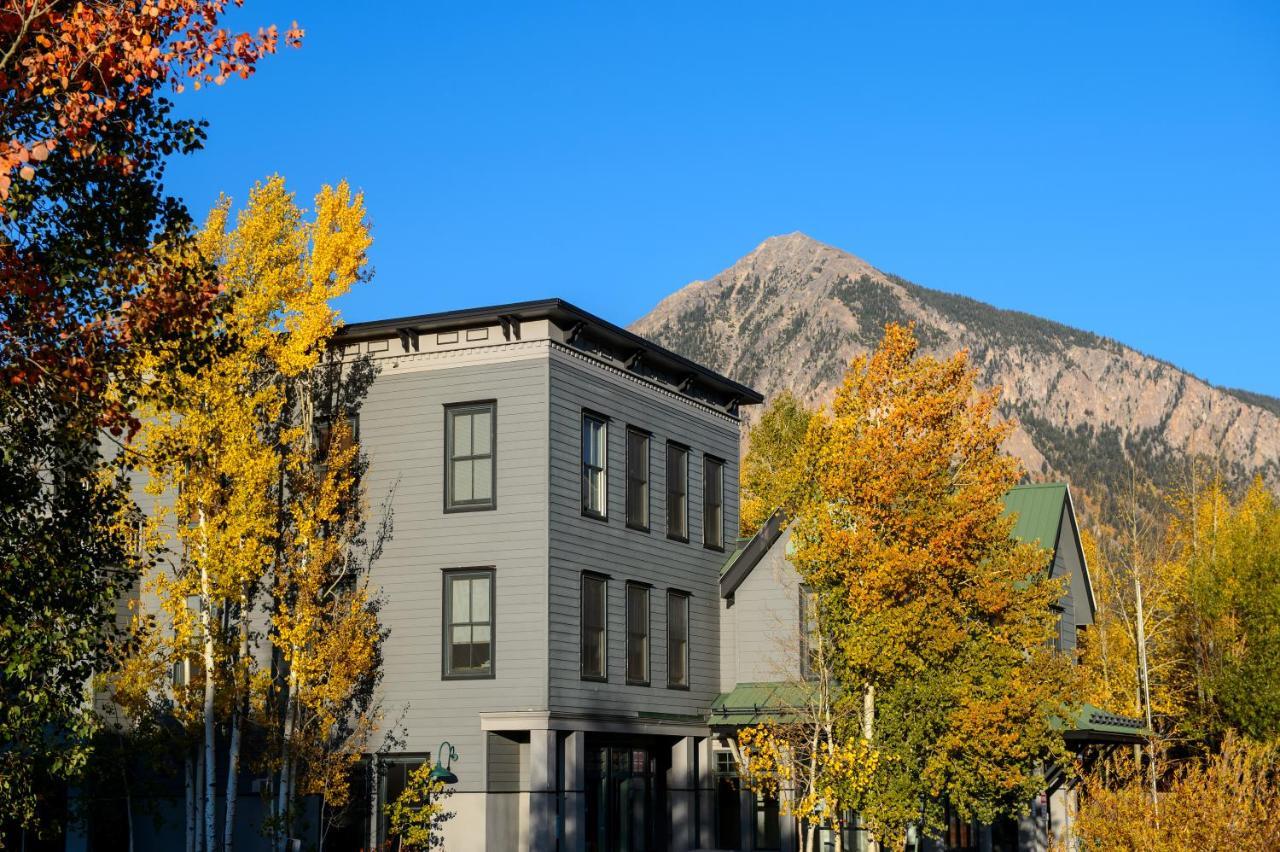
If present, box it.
[631,233,1280,509]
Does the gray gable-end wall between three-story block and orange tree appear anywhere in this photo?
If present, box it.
[721,530,800,692]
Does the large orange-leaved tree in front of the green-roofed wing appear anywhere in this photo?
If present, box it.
[744,325,1075,842]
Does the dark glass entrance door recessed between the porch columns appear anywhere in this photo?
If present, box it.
[586,746,659,852]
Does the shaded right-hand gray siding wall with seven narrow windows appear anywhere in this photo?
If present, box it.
[550,349,740,715]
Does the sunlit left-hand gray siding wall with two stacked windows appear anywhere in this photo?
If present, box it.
[360,344,548,798]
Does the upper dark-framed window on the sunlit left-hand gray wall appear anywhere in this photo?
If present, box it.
[444,402,498,512]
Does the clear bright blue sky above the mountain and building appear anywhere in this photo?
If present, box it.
[169,0,1280,395]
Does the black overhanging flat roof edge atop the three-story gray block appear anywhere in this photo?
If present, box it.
[337,298,764,404]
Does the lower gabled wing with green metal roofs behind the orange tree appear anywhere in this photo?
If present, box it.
[710,484,1144,852]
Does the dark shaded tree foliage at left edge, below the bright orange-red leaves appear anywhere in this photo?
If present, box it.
[0,100,204,825]
